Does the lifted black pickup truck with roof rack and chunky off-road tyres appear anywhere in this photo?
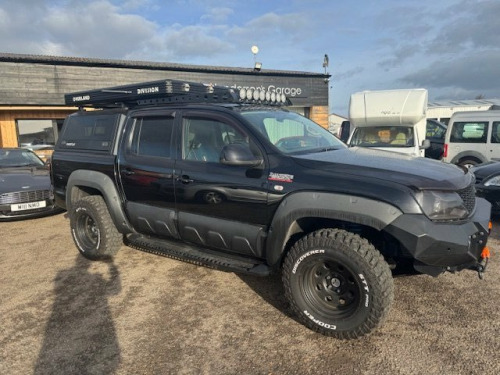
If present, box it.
[51,80,490,339]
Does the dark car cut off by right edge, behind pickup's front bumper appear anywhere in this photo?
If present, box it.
[471,161,500,214]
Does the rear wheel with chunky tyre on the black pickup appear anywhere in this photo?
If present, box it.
[70,195,123,260]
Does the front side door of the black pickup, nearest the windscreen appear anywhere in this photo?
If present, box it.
[175,110,269,257]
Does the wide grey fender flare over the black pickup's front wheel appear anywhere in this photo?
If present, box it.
[266,192,403,266]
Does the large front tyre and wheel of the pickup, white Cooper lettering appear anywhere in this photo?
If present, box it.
[282,229,394,339]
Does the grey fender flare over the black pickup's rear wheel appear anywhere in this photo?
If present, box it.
[66,169,135,234]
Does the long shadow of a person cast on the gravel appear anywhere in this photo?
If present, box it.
[34,255,121,375]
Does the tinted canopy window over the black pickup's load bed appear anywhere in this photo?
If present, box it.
[58,113,120,151]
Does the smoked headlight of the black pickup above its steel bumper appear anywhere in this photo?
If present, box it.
[417,190,469,220]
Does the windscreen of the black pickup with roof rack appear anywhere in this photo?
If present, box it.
[242,111,346,154]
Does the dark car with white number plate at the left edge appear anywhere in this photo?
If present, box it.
[0,148,62,221]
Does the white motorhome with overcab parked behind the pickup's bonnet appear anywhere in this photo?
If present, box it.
[347,89,430,156]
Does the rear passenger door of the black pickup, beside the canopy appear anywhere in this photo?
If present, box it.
[118,111,179,238]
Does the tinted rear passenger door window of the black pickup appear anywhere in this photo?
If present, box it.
[130,117,174,158]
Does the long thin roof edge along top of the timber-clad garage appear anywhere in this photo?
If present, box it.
[0,53,330,77]
